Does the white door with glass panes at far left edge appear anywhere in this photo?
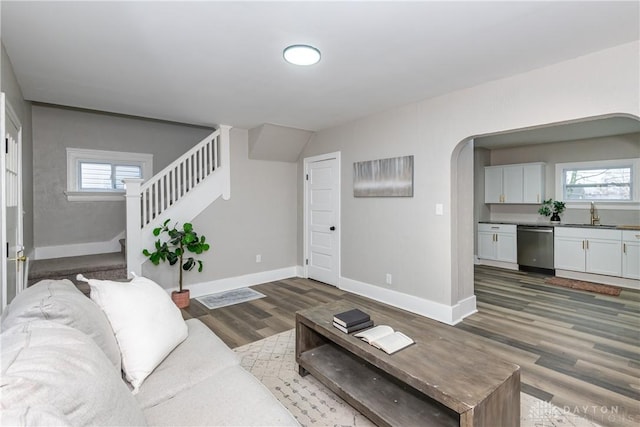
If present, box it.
[0,94,26,309]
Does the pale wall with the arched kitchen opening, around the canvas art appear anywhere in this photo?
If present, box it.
[298,42,640,320]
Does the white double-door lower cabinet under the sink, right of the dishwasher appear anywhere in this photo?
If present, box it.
[554,227,622,276]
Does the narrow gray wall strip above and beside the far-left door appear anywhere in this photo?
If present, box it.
[0,45,34,256]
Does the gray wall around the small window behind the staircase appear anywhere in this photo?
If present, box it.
[33,104,212,247]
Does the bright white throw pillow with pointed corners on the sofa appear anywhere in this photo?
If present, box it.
[88,277,187,394]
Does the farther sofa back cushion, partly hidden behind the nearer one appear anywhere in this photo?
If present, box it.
[2,279,121,372]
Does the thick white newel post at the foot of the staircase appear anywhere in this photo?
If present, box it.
[124,178,144,278]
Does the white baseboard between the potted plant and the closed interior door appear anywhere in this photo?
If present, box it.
[181,266,299,298]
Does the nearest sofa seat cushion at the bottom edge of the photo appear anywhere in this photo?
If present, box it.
[144,366,298,426]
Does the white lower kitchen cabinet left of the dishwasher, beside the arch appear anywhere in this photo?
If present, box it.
[478,224,518,263]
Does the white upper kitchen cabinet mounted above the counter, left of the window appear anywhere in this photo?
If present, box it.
[484,163,545,204]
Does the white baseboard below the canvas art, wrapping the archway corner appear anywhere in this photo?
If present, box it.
[339,277,477,325]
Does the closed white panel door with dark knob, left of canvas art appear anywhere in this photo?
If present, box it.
[305,153,340,286]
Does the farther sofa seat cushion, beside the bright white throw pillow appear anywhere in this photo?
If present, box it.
[136,319,240,409]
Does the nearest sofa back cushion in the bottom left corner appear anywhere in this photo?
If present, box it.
[0,320,146,426]
